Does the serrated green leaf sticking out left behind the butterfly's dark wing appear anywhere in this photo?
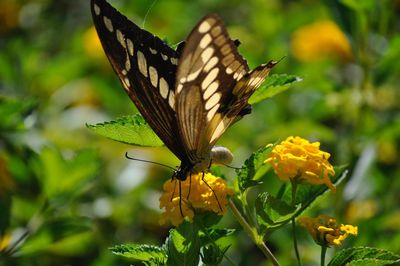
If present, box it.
[86,114,164,147]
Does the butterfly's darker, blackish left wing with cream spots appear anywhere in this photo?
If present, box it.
[91,0,186,159]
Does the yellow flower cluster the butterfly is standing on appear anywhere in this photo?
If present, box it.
[160,173,233,226]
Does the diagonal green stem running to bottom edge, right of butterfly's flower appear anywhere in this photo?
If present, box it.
[229,199,280,266]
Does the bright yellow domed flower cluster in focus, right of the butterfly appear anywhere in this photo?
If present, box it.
[265,137,336,191]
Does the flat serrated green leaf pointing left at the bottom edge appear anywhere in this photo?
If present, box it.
[110,244,167,263]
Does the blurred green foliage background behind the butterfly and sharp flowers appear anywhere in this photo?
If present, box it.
[0,0,400,266]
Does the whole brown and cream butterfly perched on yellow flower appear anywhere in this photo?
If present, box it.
[91,0,276,181]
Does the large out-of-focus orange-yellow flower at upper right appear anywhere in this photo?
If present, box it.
[291,20,352,62]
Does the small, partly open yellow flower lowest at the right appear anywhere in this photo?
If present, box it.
[299,215,358,246]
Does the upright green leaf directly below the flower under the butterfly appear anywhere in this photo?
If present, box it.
[167,221,201,266]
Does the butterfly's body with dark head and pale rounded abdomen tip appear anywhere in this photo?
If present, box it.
[174,146,233,181]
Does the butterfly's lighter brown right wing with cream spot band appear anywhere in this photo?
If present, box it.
[176,15,276,163]
